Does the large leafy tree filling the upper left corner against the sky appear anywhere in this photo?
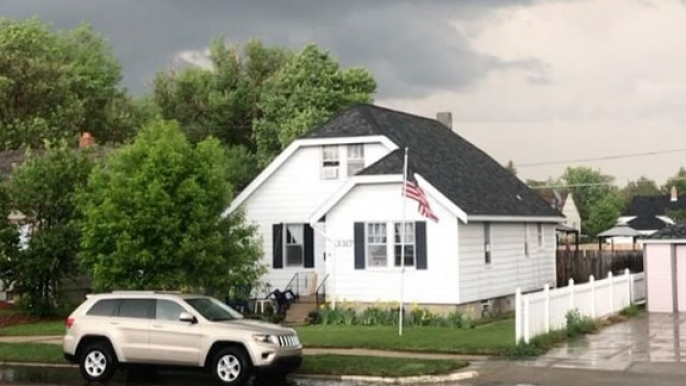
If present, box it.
[0,18,141,149]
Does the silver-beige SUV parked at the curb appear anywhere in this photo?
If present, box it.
[63,291,302,385]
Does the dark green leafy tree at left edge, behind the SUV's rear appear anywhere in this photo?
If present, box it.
[2,141,92,315]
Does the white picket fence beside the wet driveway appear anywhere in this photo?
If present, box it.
[515,269,646,343]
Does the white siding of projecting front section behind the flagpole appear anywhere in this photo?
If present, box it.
[326,183,459,304]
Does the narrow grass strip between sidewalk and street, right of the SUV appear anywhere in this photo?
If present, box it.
[298,354,468,377]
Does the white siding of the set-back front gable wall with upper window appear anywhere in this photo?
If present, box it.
[242,143,388,296]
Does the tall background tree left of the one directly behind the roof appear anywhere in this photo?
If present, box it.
[153,40,290,151]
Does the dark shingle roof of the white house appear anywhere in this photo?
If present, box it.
[305,104,562,217]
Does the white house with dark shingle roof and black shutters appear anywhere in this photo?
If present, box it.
[226,104,564,316]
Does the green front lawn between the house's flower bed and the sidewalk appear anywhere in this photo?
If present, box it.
[297,319,515,355]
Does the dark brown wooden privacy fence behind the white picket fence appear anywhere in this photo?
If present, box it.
[556,250,643,287]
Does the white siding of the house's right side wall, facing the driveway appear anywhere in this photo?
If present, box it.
[459,222,556,303]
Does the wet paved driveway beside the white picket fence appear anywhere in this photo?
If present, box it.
[528,313,686,371]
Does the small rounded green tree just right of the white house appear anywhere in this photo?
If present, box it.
[562,166,616,226]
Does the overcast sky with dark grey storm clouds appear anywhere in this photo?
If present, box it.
[0,0,686,185]
